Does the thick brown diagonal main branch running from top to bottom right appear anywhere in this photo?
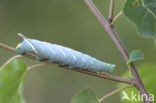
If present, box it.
[85,0,152,103]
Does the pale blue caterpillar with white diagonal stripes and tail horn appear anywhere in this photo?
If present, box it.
[16,33,115,73]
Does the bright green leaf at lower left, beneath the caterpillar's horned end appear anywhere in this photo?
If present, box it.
[0,59,27,103]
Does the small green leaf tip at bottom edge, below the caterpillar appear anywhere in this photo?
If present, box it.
[71,88,99,103]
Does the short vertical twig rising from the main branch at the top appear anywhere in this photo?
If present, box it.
[108,0,114,24]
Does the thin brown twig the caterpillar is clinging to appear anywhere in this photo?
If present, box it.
[0,43,136,84]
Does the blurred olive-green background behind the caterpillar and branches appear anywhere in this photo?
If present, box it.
[0,0,156,103]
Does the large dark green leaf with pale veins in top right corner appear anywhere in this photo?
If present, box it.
[123,0,156,38]
